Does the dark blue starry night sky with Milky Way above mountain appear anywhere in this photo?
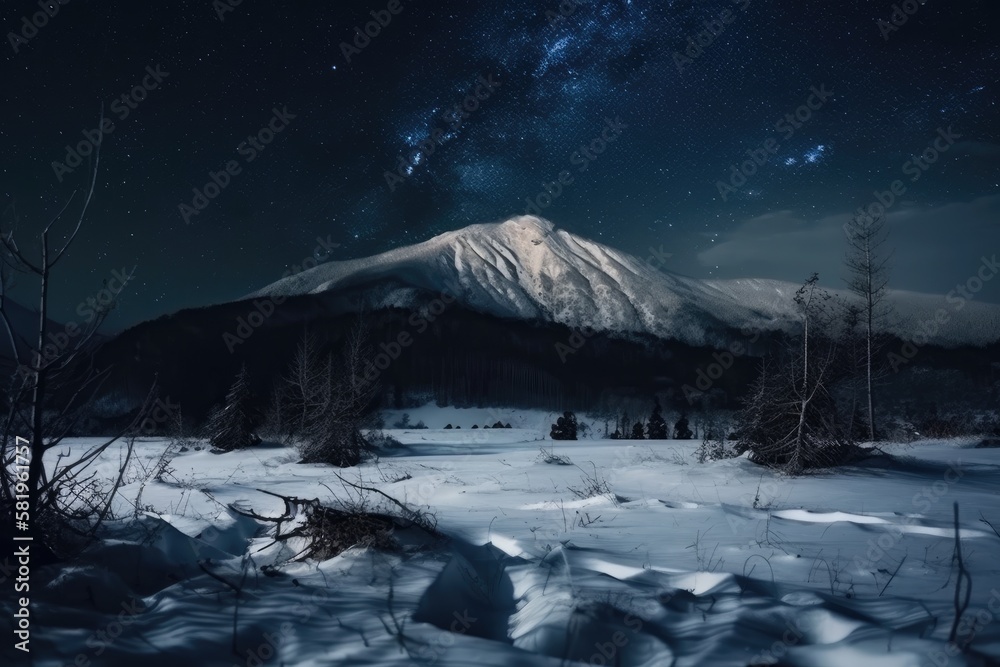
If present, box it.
[0,0,1000,328]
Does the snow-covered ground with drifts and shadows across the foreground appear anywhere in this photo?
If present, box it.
[0,409,1000,667]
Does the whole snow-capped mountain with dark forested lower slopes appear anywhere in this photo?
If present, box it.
[76,216,1000,424]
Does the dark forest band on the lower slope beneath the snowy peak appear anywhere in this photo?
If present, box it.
[92,295,754,432]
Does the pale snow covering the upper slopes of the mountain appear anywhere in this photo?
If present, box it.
[248,216,1000,345]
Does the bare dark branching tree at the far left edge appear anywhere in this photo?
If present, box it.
[0,110,155,556]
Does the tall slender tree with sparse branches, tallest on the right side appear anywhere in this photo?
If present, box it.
[844,213,892,441]
